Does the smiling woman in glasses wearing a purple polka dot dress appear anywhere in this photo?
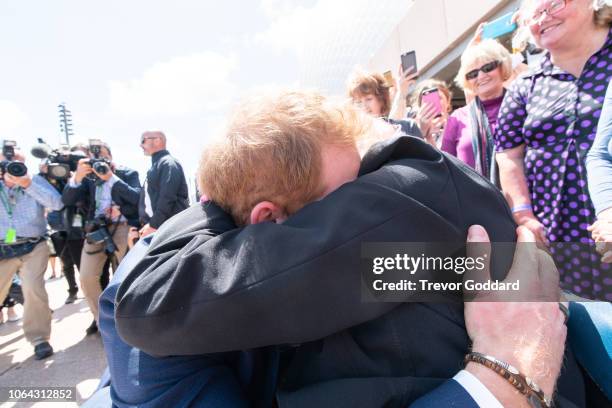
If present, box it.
[494,0,612,300]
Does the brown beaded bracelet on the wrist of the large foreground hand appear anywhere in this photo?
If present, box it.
[465,351,552,408]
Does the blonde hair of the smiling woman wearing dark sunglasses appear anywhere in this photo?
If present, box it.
[455,39,512,91]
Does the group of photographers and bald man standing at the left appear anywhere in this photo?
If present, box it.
[0,131,189,359]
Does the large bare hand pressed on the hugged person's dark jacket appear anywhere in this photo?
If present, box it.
[465,226,567,407]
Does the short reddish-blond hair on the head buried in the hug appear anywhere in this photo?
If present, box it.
[198,91,367,225]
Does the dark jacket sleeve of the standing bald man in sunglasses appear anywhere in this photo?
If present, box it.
[149,157,185,228]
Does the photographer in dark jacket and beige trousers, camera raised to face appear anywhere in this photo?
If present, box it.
[62,140,140,334]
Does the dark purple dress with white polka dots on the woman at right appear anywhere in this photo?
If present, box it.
[494,30,612,300]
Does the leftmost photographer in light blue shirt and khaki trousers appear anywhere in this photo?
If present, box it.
[0,141,63,360]
